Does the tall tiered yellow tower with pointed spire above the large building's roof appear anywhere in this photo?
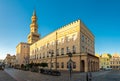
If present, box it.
[28,10,40,44]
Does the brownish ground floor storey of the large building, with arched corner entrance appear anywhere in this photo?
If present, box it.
[30,53,99,72]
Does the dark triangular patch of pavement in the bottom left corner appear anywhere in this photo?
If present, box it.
[0,70,16,81]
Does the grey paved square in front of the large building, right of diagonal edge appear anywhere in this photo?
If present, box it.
[3,69,120,81]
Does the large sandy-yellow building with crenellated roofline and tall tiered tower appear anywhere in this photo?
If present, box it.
[16,11,99,72]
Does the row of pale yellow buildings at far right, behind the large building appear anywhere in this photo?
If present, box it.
[96,53,120,70]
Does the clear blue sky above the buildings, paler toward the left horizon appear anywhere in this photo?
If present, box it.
[0,0,120,59]
